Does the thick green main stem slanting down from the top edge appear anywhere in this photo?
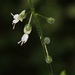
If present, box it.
[29,0,46,60]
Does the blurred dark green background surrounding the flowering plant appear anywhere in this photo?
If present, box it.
[0,0,75,75]
